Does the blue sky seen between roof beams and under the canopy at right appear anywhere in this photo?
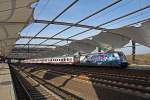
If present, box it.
[17,0,150,54]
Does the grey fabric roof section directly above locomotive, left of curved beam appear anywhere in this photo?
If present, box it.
[92,32,130,48]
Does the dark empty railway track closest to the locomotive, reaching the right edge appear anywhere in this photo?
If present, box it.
[60,70,150,87]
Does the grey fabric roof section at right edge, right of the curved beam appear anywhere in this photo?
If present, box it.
[109,20,150,47]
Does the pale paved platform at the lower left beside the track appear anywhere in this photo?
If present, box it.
[0,63,16,100]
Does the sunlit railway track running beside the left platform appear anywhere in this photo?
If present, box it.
[10,67,82,100]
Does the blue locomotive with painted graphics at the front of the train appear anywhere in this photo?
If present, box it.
[81,52,128,66]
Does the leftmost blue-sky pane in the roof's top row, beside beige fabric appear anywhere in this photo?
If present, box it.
[34,0,73,20]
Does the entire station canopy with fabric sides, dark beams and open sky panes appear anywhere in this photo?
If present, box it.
[3,0,150,57]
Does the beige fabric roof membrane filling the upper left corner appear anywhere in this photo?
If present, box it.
[0,0,36,56]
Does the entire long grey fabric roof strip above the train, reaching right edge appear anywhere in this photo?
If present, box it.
[53,20,150,56]
